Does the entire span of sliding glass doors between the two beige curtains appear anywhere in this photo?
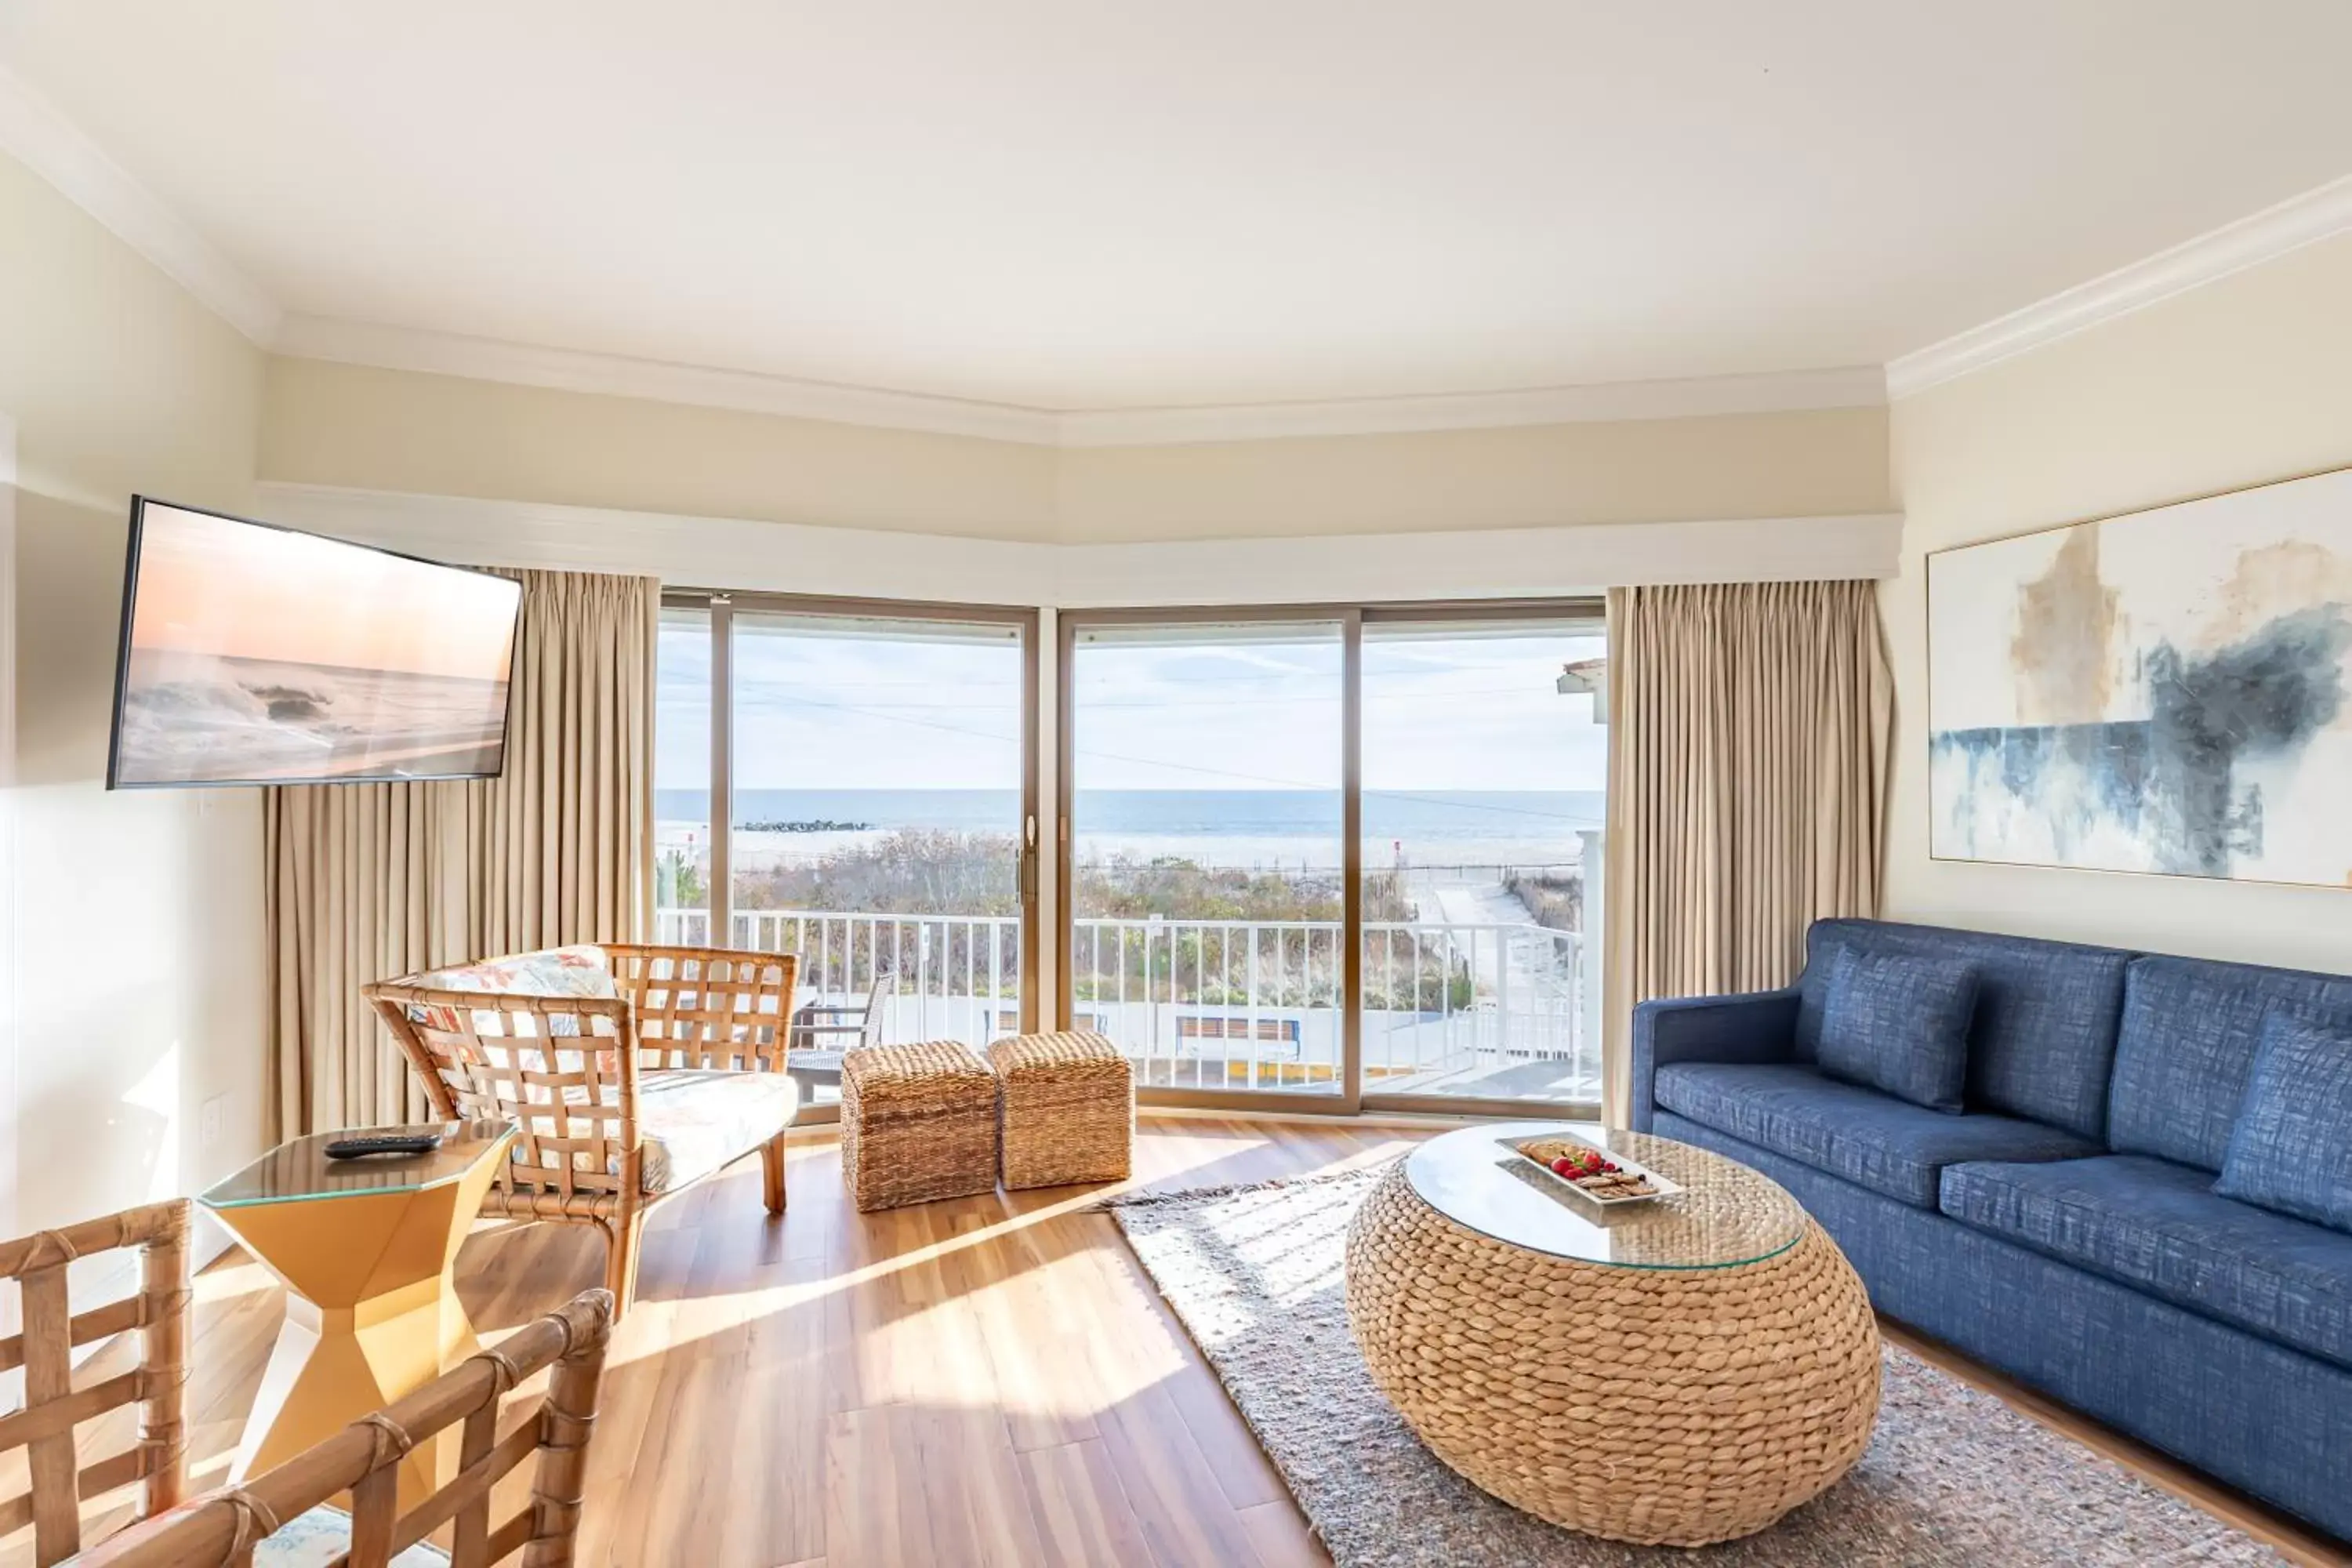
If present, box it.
[654,593,1609,1114]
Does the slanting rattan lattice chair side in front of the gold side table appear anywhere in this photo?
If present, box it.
[80,1290,612,1568]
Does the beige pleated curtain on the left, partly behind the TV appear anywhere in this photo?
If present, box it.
[263,572,661,1138]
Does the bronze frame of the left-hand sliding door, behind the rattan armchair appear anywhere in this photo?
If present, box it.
[647,588,1047,1091]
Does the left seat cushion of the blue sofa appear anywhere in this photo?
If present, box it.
[1658,1062,2098,1208]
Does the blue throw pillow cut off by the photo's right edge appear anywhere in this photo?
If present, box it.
[2213,1008,2352,1229]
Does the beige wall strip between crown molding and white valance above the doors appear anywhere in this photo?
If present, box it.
[261,360,1889,543]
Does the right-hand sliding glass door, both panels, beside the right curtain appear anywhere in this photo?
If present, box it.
[1061,604,1609,1114]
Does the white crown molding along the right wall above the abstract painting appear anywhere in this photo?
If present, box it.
[1886,176,2352,397]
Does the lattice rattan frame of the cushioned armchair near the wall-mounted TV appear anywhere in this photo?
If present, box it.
[362,942,800,1316]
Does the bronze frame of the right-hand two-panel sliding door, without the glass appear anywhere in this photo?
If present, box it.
[1054,595,1616,1121]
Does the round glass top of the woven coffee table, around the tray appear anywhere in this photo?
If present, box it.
[1404,1121,1804,1269]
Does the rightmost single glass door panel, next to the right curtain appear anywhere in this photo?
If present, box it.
[1362,612,1609,1109]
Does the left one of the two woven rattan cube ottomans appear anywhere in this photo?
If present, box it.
[842,1039,997,1213]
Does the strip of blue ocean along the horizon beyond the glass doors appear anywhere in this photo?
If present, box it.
[673,789,1604,867]
